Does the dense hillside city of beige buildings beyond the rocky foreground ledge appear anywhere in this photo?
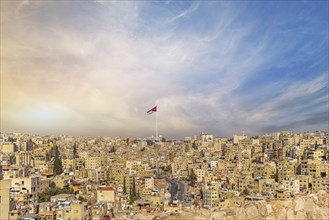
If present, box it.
[0,131,329,220]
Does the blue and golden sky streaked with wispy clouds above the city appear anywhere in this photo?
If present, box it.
[0,0,329,139]
